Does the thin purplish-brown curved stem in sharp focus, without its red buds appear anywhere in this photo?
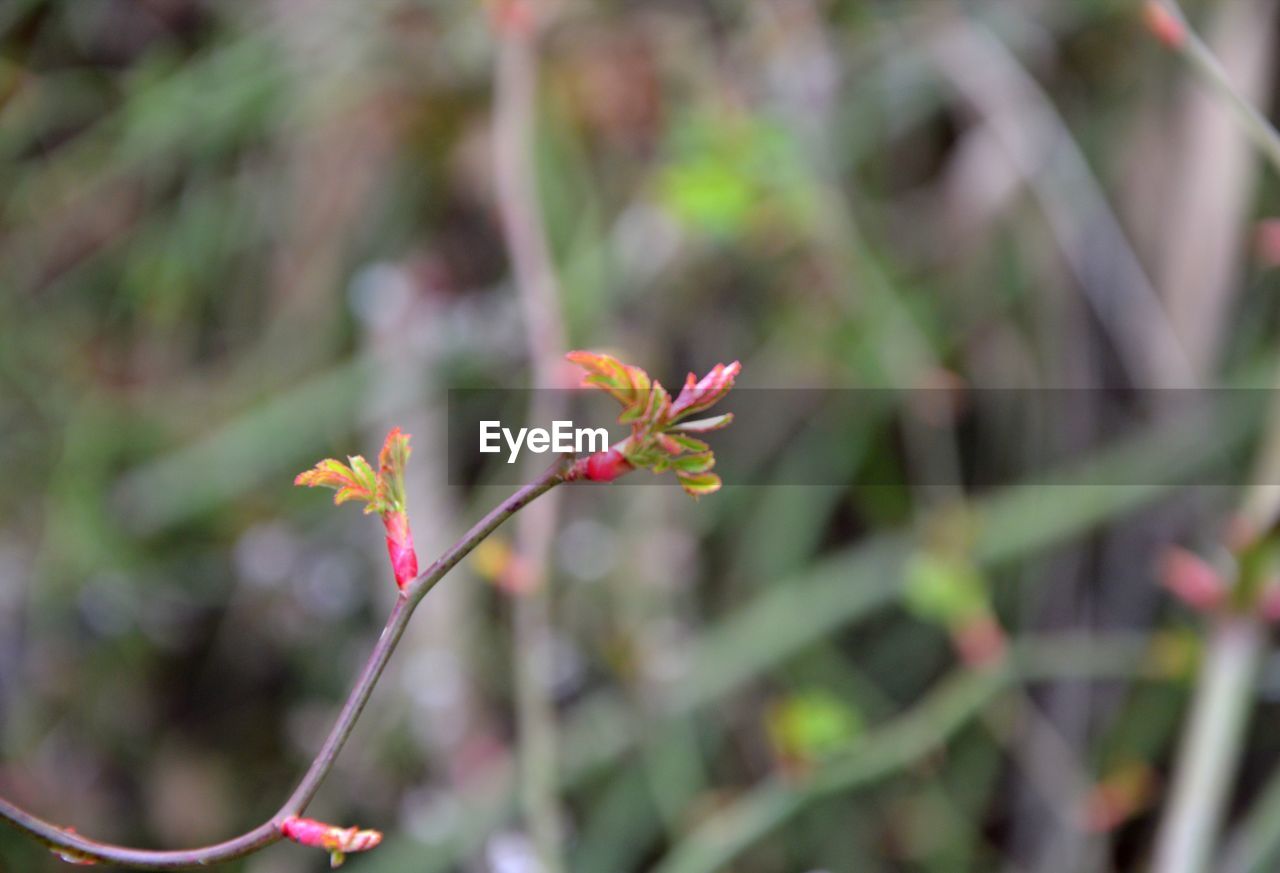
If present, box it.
[0,458,570,870]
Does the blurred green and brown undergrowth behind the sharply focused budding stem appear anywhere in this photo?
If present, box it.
[0,0,1280,873]
